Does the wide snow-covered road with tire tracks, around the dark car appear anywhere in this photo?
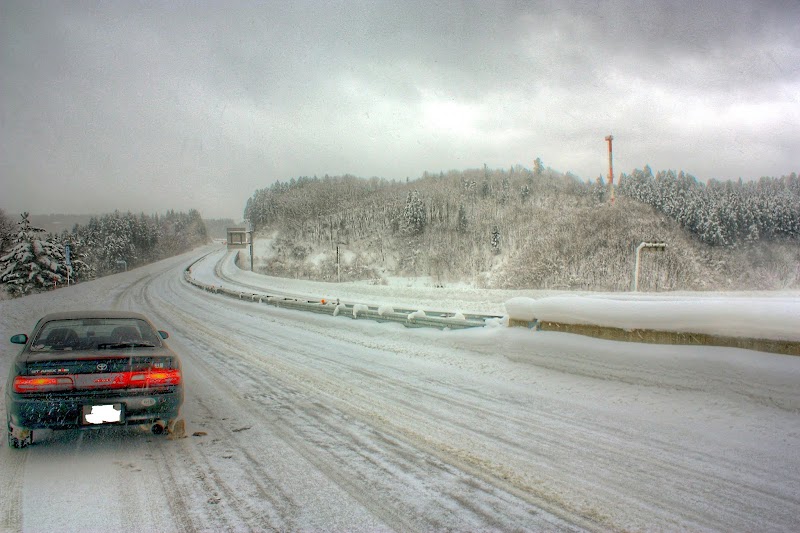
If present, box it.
[0,250,800,531]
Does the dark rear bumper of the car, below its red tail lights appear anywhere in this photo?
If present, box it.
[6,388,183,429]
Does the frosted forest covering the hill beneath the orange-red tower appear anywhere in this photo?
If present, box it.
[244,163,800,291]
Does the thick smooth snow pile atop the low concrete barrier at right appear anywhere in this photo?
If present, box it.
[505,295,800,341]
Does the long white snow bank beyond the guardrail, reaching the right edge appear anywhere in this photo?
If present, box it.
[192,249,800,341]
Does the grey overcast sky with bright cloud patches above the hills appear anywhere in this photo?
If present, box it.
[0,0,800,220]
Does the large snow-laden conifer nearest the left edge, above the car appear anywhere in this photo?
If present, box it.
[0,212,66,296]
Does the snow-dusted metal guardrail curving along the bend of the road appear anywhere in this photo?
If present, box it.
[183,254,502,329]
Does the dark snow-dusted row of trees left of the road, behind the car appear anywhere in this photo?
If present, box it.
[0,209,208,297]
